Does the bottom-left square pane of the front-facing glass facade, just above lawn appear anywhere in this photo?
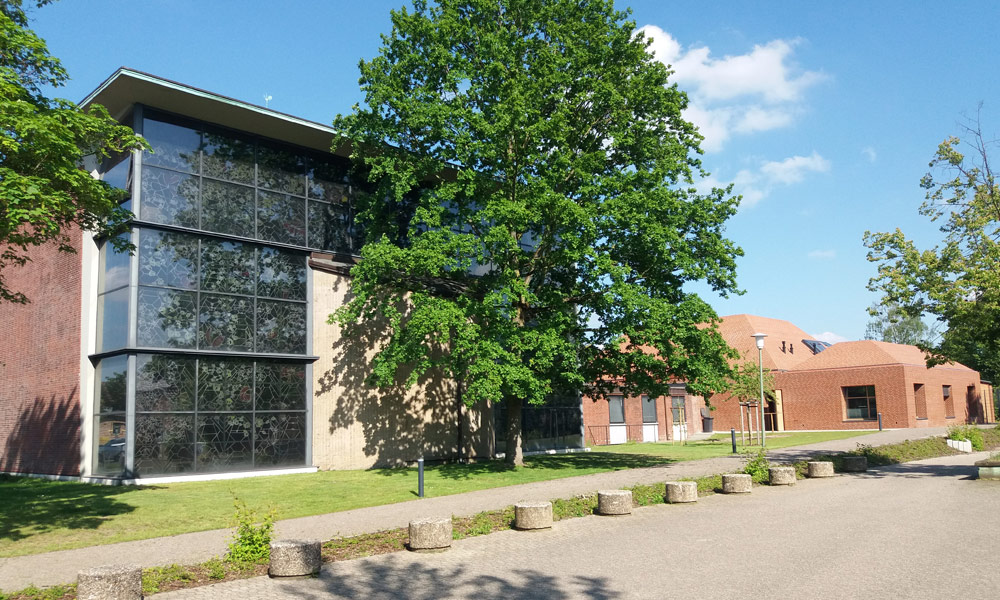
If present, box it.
[135,413,194,476]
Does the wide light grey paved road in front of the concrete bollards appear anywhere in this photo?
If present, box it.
[157,453,1000,600]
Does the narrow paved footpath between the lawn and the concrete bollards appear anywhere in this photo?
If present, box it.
[0,428,946,591]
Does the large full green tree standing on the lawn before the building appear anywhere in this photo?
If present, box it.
[333,0,742,465]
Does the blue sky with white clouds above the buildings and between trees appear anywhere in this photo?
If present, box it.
[32,0,1000,341]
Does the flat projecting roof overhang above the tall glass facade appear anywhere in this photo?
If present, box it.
[80,67,347,156]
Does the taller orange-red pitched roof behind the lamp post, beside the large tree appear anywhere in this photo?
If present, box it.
[719,314,829,371]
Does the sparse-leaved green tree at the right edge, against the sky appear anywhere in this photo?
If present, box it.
[865,115,1000,381]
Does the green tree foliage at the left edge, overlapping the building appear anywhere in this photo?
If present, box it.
[0,0,143,302]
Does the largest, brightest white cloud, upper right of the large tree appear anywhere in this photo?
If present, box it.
[639,25,826,152]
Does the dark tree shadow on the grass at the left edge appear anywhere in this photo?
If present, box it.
[0,475,146,542]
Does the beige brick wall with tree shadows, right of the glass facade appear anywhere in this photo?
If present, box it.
[313,269,493,469]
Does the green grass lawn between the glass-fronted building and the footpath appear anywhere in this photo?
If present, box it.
[0,432,857,557]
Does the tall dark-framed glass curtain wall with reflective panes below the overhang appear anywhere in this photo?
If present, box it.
[94,110,361,477]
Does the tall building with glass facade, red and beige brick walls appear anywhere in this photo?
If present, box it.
[0,68,583,480]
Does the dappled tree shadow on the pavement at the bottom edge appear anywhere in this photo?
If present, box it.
[291,559,621,600]
